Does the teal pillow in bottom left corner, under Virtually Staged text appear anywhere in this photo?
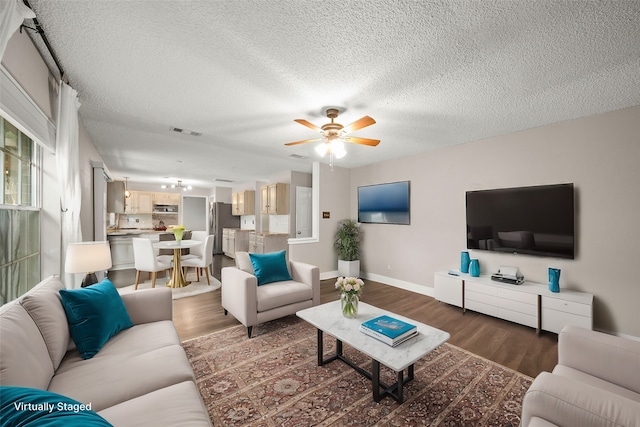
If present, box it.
[0,386,111,427]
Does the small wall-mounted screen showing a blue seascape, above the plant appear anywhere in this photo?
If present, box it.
[358,181,411,225]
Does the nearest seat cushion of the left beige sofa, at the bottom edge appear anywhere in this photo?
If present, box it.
[100,381,211,427]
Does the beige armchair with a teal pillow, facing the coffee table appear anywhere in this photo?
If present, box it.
[222,252,320,338]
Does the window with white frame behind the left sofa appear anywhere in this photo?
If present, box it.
[0,117,42,304]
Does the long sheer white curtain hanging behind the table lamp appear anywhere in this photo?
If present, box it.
[56,82,82,289]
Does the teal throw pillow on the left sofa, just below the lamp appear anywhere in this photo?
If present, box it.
[60,279,133,359]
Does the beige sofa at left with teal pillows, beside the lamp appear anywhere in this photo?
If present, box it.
[0,277,211,427]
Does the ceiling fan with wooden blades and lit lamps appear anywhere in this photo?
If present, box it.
[285,108,380,151]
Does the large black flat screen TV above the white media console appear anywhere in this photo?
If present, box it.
[466,184,575,259]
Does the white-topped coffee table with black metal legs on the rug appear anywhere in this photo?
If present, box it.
[296,301,450,403]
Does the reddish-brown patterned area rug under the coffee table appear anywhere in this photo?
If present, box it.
[182,316,532,426]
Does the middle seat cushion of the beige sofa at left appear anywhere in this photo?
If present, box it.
[49,342,195,411]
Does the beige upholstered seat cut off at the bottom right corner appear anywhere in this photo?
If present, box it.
[522,326,640,427]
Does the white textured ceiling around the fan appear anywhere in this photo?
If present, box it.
[22,0,640,188]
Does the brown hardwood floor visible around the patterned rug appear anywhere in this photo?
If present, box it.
[173,255,558,377]
